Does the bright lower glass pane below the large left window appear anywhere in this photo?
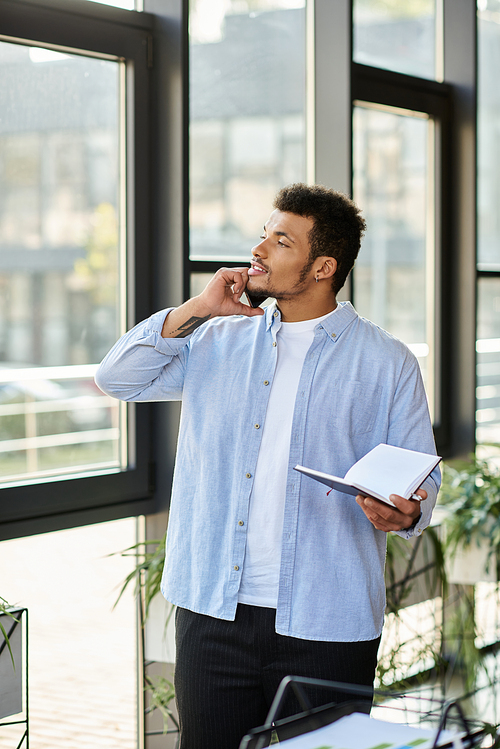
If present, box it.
[0,518,137,749]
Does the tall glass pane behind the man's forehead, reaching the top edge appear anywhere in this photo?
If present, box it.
[189,0,305,260]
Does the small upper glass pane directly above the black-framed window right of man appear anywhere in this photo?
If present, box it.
[353,0,436,79]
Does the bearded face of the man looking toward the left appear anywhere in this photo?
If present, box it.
[247,210,315,299]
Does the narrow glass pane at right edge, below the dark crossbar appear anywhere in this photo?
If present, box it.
[476,278,500,456]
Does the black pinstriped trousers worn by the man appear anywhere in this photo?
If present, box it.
[174,604,380,749]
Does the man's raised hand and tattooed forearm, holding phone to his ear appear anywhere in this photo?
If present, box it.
[161,268,264,338]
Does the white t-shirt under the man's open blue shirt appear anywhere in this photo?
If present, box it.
[238,312,333,608]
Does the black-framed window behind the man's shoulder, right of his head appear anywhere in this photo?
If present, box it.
[352,65,450,450]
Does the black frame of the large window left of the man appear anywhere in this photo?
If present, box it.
[0,0,155,539]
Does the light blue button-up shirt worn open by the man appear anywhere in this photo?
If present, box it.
[96,302,440,642]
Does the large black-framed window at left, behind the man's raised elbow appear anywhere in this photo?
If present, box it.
[0,3,151,536]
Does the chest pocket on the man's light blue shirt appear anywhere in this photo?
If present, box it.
[334,380,382,435]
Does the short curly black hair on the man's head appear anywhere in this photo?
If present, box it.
[273,182,366,294]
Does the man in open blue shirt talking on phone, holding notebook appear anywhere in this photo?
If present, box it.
[97,184,439,749]
